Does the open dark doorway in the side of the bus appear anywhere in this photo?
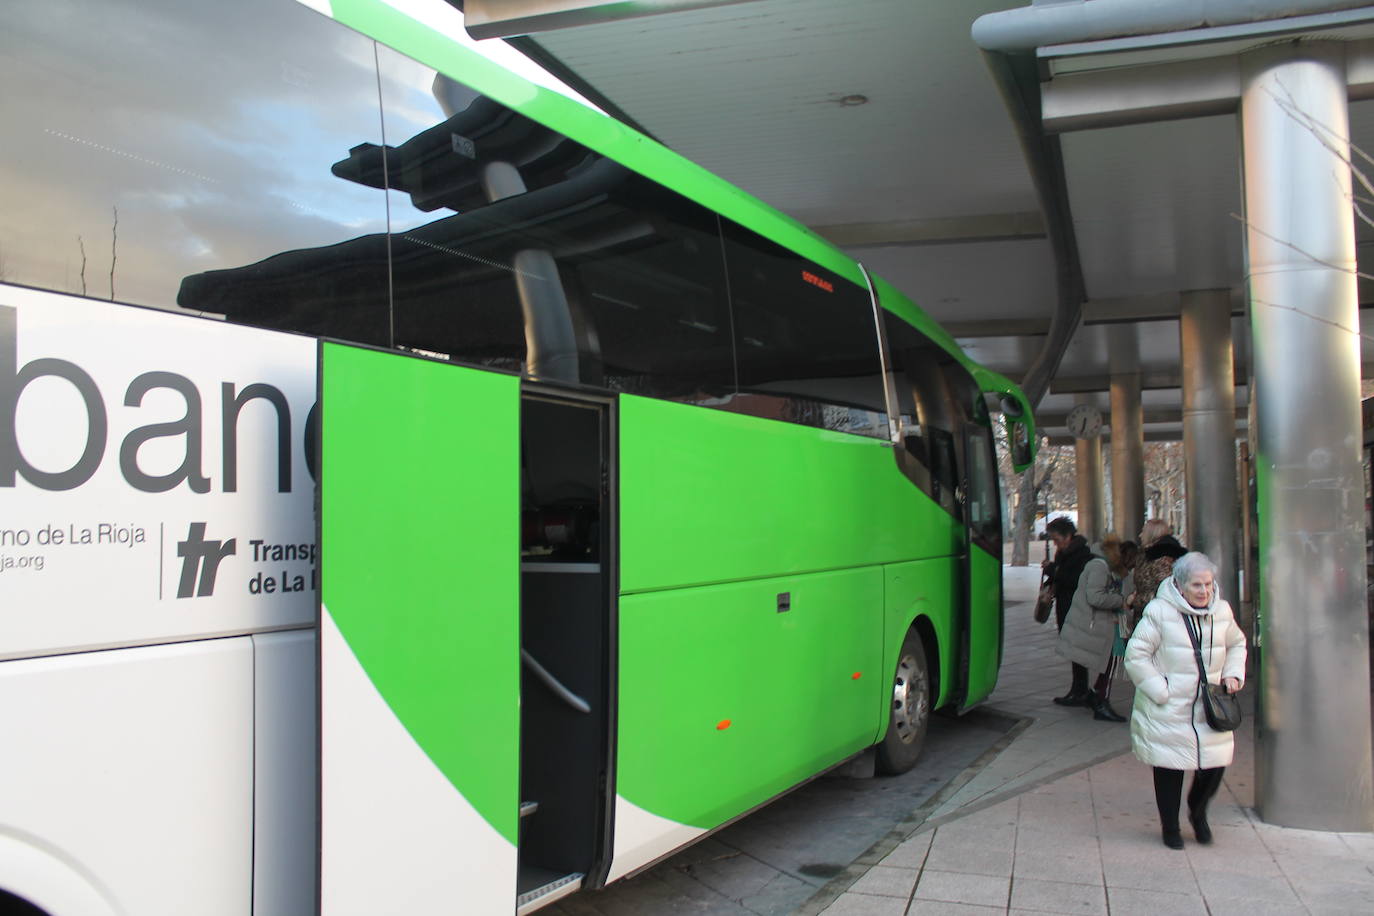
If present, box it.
[517,386,614,912]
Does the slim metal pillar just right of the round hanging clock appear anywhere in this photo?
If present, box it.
[1107,325,1145,540]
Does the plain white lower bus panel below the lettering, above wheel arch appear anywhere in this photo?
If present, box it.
[0,637,253,916]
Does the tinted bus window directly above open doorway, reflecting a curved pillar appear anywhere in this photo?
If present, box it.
[365,48,734,401]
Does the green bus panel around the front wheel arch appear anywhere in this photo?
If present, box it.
[879,556,960,708]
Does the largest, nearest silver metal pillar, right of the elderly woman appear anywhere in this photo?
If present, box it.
[1241,41,1374,831]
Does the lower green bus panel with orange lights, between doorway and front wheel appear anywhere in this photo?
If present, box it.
[616,569,888,829]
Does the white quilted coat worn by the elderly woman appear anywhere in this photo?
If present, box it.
[1125,575,1245,769]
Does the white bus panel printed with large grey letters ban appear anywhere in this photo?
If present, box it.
[0,284,316,659]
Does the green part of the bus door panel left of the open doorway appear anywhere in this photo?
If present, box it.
[320,343,519,843]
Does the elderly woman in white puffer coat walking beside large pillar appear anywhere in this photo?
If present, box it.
[1125,552,1245,849]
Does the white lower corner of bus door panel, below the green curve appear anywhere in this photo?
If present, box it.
[320,608,515,916]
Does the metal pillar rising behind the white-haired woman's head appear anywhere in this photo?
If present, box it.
[1179,290,1239,611]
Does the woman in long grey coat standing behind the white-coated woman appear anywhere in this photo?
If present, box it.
[1058,534,1127,722]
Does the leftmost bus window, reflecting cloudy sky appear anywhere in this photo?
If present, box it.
[0,0,386,329]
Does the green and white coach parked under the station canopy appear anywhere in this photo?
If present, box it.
[0,0,1035,916]
